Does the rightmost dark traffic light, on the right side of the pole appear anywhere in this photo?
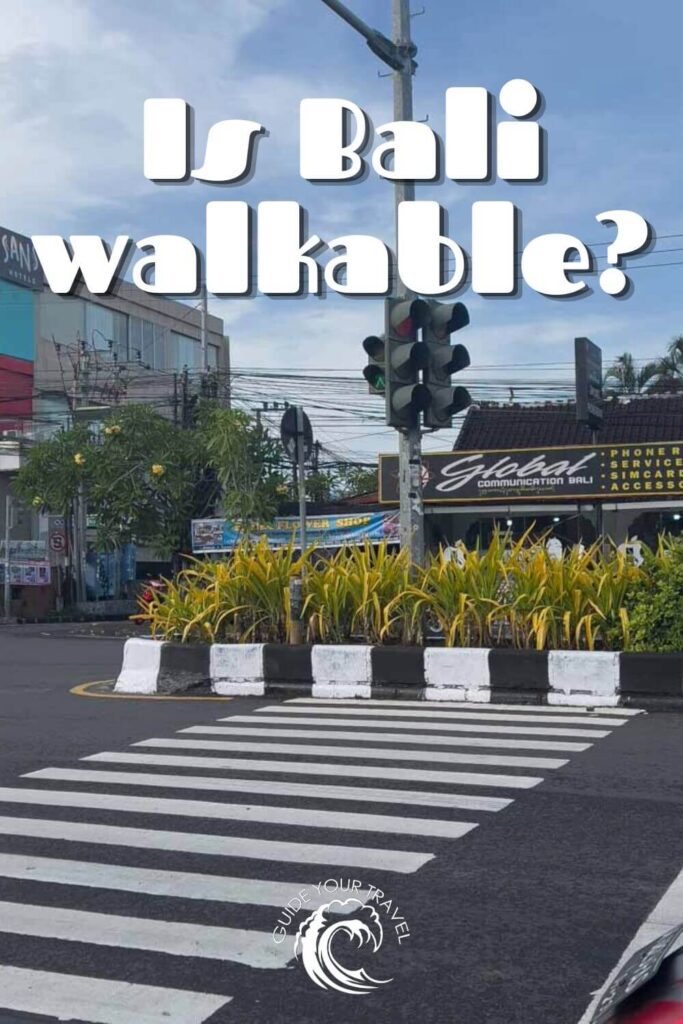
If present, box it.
[422,300,472,429]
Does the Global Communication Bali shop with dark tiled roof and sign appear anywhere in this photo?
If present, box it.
[379,394,683,548]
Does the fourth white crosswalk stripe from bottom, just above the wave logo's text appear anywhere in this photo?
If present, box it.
[0,817,434,874]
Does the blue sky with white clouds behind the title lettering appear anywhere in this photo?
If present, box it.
[0,0,683,454]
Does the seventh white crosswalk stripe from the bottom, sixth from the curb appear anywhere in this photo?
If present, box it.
[81,751,543,790]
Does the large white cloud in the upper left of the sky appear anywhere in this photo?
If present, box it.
[0,0,300,233]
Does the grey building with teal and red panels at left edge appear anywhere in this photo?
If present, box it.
[0,227,229,600]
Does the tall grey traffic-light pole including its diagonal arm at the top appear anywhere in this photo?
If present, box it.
[323,0,425,565]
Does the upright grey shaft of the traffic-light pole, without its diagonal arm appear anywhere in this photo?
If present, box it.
[392,0,425,565]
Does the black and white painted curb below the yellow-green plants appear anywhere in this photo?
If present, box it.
[116,639,683,708]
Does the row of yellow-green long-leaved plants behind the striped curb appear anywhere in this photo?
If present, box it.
[137,530,659,650]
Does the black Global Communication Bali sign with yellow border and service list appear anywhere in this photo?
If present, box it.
[380,441,683,505]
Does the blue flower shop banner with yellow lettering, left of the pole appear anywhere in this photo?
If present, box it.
[193,512,398,555]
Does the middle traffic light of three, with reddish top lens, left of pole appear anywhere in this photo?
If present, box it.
[385,299,430,429]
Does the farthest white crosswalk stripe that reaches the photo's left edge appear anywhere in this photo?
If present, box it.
[0,787,476,839]
